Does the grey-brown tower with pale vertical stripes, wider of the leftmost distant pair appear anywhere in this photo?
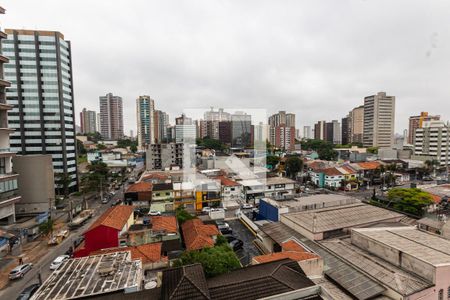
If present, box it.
[99,93,123,140]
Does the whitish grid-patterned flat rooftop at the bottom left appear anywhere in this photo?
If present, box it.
[32,251,142,300]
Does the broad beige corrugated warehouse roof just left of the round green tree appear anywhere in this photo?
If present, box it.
[283,203,403,233]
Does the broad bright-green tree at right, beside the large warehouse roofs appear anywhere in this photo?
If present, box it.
[388,188,433,217]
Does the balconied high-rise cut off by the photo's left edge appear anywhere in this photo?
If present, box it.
[0,7,21,224]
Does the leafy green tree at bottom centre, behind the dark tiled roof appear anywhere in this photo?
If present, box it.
[174,243,241,278]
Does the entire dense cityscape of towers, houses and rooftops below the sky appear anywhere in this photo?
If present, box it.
[0,2,450,300]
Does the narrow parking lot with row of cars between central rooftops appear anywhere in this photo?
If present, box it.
[227,219,260,266]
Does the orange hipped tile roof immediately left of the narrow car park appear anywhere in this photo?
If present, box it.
[182,219,219,251]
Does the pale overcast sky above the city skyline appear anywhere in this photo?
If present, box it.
[0,0,450,134]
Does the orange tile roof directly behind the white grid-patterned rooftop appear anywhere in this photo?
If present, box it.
[90,243,167,264]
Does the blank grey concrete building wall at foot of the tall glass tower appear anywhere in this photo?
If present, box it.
[13,154,55,214]
